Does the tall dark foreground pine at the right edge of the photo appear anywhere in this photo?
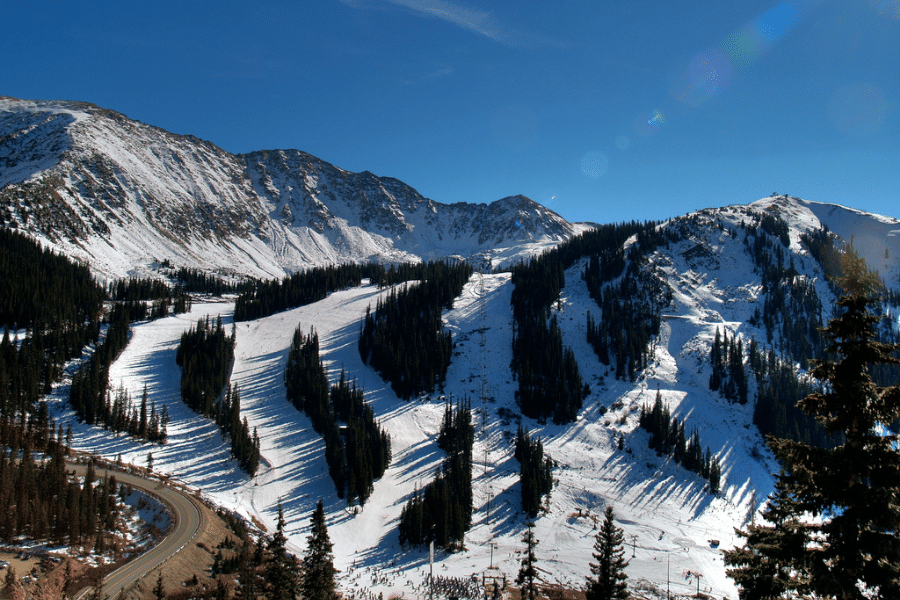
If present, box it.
[725,249,900,600]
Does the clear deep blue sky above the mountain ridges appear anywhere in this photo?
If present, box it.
[0,0,900,222]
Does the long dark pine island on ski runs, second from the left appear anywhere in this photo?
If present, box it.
[284,325,391,506]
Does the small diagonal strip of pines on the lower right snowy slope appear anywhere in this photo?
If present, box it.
[640,390,722,494]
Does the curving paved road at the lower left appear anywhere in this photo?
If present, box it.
[69,464,202,600]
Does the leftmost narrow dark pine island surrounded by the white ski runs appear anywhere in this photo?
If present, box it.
[175,315,260,477]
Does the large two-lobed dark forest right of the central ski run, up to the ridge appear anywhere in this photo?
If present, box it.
[511,222,677,424]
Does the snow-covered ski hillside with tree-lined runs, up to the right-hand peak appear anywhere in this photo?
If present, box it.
[29,196,900,597]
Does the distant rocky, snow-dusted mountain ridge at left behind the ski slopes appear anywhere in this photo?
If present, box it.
[0,97,584,277]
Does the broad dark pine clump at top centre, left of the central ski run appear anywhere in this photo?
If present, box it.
[359,261,472,398]
